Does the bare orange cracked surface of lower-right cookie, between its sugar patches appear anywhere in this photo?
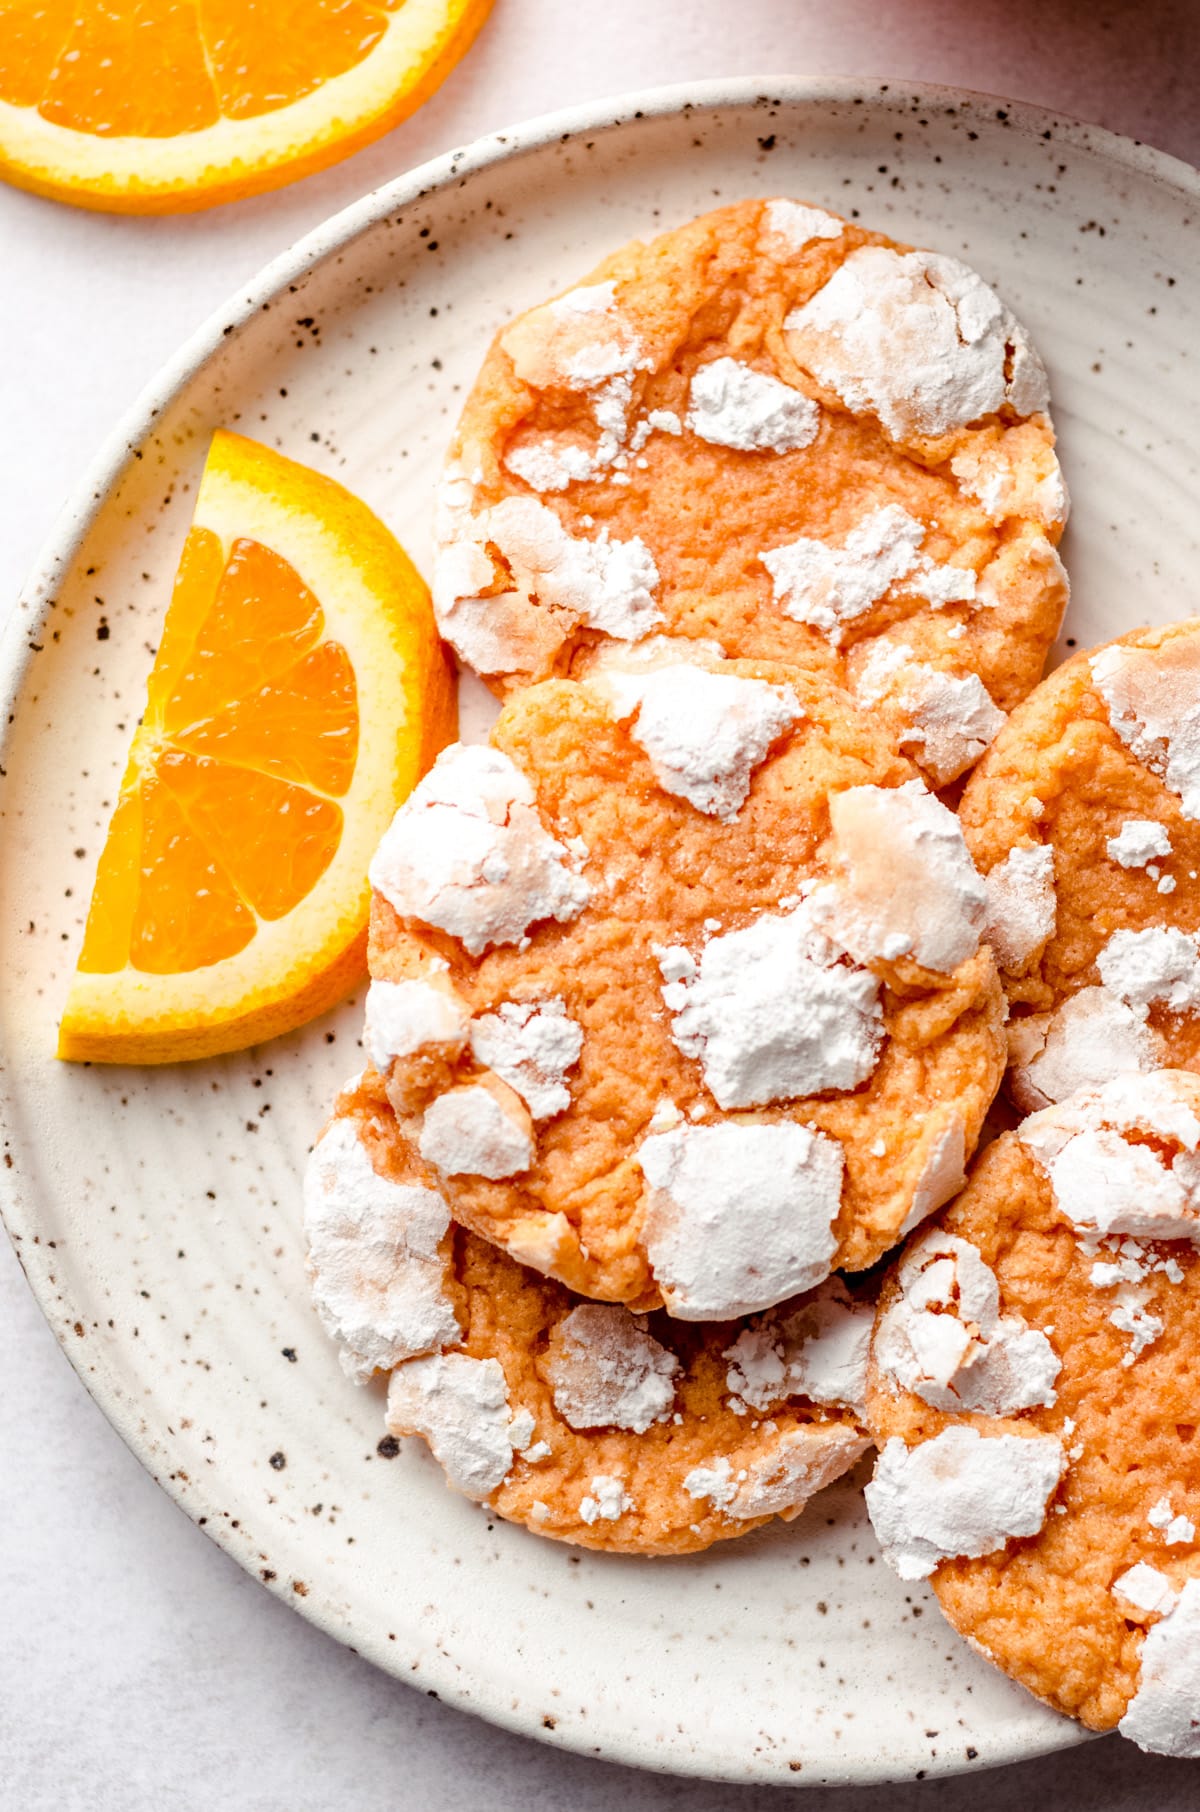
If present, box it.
[868,1076,1200,1730]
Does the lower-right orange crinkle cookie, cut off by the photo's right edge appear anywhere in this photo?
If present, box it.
[866,1071,1200,1756]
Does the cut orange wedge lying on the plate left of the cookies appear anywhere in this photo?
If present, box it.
[58,433,457,1064]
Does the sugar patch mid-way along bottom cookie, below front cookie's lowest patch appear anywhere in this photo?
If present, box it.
[546,1303,682,1435]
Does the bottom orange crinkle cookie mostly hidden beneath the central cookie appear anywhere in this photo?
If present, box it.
[305,1078,872,1555]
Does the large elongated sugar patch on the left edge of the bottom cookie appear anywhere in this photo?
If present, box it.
[305,1120,459,1384]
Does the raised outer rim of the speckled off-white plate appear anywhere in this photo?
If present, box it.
[0,76,1200,1785]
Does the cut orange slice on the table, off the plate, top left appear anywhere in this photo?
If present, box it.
[0,0,491,214]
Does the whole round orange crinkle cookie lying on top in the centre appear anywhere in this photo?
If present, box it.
[358,643,1004,1321]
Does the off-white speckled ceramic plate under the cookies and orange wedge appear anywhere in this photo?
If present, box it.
[0,80,1200,1783]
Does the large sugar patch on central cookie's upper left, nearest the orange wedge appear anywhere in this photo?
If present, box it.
[370,743,591,957]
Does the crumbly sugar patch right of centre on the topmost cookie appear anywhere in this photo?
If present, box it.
[760,504,977,647]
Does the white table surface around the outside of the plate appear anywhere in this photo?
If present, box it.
[0,0,1200,1812]
